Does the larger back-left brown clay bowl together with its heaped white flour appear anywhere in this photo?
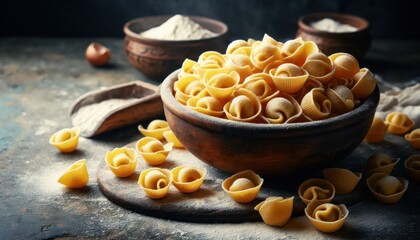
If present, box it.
[124,15,228,81]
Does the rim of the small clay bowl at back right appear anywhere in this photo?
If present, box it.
[298,12,370,36]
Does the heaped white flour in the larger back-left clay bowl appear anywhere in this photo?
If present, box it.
[140,15,216,41]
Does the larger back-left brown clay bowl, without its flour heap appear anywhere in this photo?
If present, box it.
[124,16,228,80]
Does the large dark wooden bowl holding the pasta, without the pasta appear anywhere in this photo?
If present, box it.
[161,71,379,176]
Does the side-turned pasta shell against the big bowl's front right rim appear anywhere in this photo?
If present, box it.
[300,88,332,120]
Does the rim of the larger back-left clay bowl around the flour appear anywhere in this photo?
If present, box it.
[123,15,229,44]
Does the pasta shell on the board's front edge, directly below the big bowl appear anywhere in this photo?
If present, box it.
[222,170,264,203]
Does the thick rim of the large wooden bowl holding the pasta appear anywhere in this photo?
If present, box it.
[160,69,380,138]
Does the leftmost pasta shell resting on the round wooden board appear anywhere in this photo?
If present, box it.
[105,147,137,177]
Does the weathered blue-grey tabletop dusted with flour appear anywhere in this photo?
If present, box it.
[0,38,420,239]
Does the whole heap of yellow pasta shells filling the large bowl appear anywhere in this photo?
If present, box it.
[174,34,376,124]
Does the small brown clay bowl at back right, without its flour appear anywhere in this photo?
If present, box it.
[296,13,372,61]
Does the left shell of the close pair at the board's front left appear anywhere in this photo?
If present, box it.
[137,168,172,199]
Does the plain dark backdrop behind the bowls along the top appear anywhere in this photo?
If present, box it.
[0,0,420,39]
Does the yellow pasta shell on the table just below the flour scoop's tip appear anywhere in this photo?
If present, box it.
[49,127,80,153]
